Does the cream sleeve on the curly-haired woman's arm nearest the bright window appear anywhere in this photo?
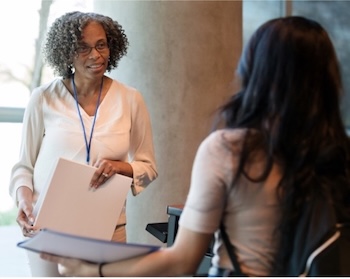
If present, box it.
[9,90,44,202]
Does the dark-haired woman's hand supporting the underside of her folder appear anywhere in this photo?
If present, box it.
[40,253,99,277]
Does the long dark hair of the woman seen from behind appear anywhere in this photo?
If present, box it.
[216,16,350,274]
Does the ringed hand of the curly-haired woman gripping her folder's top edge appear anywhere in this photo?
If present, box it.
[90,159,133,189]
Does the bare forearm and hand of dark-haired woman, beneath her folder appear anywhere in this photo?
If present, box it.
[41,227,212,277]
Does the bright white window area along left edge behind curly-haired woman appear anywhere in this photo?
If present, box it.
[0,0,93,277]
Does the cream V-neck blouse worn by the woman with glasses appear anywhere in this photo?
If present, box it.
[10,78,157,225]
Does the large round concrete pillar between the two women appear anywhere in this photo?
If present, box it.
[94,0,242,245]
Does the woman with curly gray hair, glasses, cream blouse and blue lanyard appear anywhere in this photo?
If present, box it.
[10,12,157,276]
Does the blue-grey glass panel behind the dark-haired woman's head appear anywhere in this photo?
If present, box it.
[243,0,350,130]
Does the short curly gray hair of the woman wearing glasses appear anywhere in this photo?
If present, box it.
[43,11,129,78]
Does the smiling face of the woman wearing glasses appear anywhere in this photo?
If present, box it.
[73,21,109,79]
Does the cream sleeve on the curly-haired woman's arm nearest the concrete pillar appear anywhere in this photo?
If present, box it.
[129,90,158,195]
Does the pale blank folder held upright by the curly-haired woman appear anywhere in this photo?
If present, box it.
[34,158,132,240]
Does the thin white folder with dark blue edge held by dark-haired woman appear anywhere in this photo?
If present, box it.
[17,230,160,263]
